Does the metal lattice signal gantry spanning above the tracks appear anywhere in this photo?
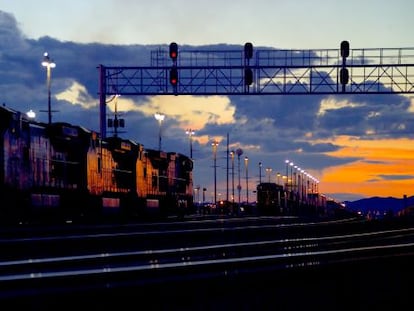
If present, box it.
[98,47,414,137]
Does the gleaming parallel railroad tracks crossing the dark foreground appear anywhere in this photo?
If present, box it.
[0,219,414,310]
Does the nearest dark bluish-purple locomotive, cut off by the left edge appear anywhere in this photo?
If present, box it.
[0,107,89,222]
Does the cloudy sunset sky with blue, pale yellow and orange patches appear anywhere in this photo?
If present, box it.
[0,0,414,201]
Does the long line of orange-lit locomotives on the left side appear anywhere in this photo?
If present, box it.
[0,106,193,223]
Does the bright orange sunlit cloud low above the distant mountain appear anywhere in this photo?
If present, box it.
[320,137,414,197]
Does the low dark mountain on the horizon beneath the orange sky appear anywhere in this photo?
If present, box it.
[344,196,414,215]
